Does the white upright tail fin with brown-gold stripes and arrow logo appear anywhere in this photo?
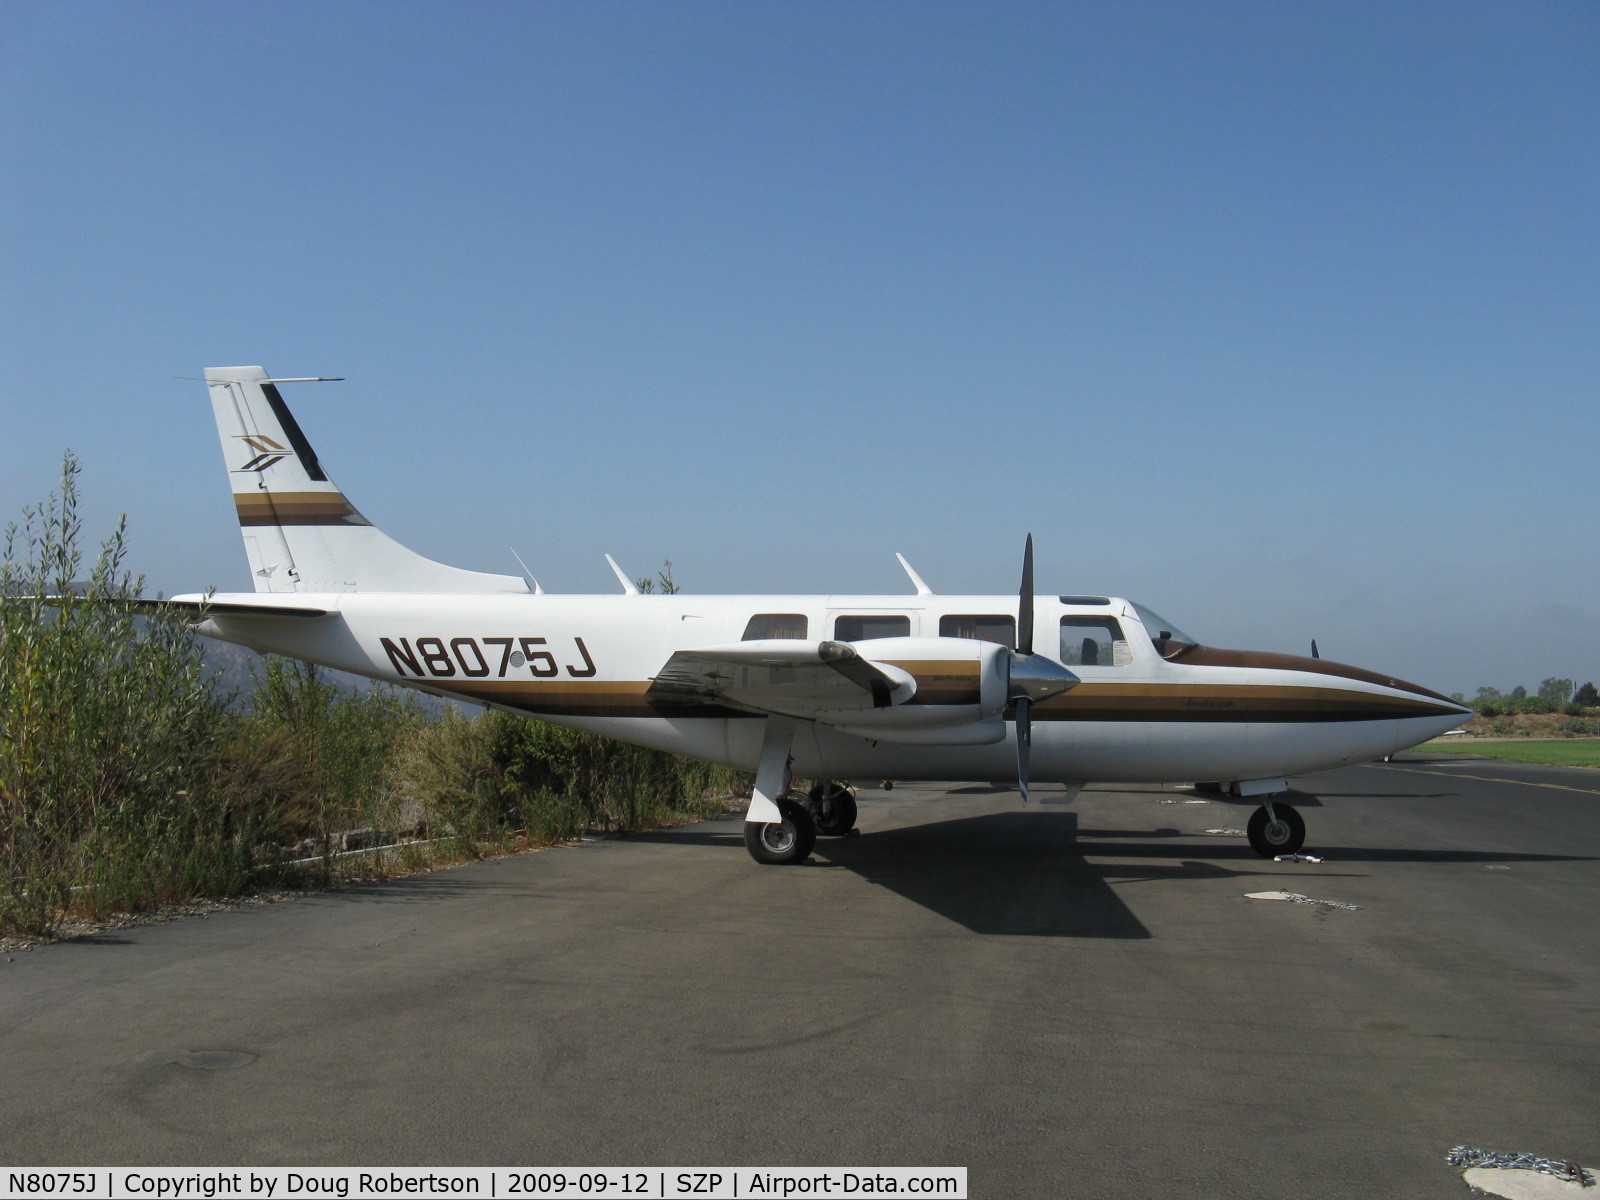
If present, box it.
[205,366,528,592]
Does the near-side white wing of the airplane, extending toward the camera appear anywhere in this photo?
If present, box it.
[645,640,917,718]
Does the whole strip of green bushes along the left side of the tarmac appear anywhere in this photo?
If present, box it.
[0,454,749,936]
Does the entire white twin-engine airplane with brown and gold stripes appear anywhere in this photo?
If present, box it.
[170,366,1469,862]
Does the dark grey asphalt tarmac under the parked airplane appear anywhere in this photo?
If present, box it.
[0,754,1600,1200]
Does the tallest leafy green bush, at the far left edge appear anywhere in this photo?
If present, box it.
[0,454,235,934]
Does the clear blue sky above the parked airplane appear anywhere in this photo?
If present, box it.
[0,0,1600,693]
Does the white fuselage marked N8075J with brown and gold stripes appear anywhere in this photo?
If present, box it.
[190,592,1466,784]
